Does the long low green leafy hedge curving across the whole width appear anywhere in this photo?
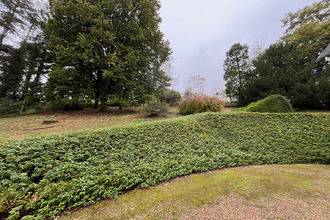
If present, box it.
[0,113,330,219]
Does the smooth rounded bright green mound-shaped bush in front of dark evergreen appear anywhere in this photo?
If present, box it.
[237,94,293,113]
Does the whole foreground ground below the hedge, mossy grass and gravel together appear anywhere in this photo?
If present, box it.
[58,164,330,220]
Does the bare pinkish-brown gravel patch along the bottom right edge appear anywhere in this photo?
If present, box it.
[178,195,330,220]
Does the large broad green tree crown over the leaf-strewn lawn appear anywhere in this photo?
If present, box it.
[45,0,170,110]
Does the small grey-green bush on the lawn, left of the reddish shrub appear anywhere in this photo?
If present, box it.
[140,96,168,116]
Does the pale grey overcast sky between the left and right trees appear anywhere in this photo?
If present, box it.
[160,0,316,93]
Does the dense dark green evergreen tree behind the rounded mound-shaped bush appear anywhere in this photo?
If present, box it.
[244,42,330,109]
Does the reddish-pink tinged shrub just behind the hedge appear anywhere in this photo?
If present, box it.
[179,94,225,115]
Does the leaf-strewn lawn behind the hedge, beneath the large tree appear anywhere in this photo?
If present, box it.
[0,108,179,143]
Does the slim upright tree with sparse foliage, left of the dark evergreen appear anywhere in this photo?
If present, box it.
[223,43,249,106]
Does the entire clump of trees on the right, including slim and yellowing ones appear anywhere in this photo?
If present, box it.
[224,0,330,109]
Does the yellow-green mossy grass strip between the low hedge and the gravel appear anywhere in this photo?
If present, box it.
[60,164,330,220]
